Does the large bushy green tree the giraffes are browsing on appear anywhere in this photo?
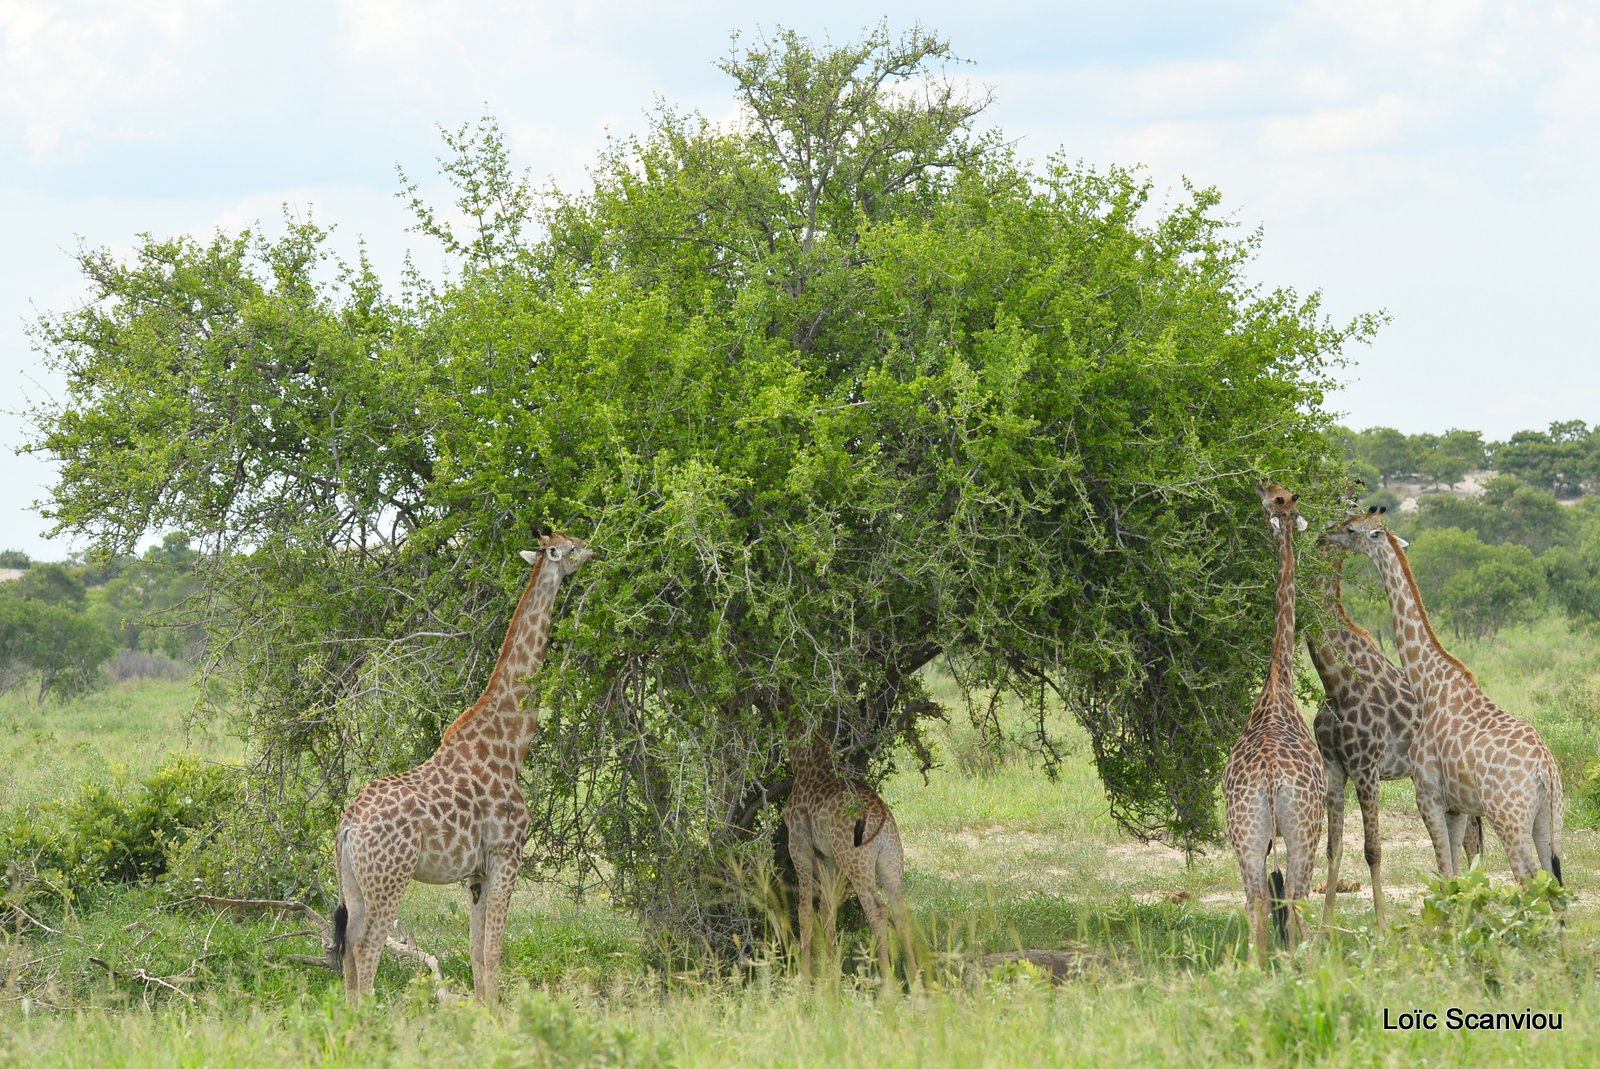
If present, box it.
[25,30,1374,935]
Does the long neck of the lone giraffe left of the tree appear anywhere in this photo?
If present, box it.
[440,555,562,765]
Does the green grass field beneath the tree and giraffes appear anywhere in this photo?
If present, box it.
[0,621,1600,1066]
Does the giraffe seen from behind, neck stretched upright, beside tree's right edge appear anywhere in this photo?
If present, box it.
[1222,483,1328,968]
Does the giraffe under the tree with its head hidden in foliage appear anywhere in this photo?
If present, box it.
[784,733,917,989]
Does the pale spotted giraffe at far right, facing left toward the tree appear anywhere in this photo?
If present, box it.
[1326,507,1563,883]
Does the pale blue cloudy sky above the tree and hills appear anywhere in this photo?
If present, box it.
[0,0,1600,559]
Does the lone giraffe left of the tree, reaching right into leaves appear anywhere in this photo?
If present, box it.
[333,528,594,1003]
